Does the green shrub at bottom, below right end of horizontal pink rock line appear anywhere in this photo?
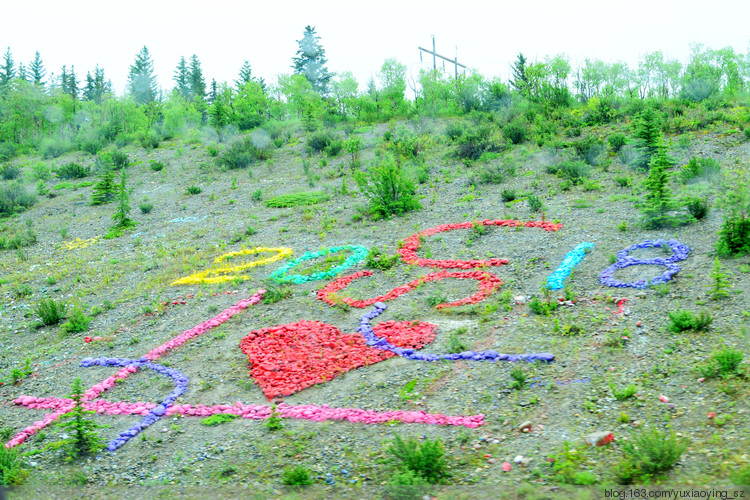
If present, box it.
[387,434,449,484]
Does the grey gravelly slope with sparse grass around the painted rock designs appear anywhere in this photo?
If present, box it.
[0,116,750,498]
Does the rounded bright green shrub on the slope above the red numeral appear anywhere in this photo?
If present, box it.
[354,155,422,217]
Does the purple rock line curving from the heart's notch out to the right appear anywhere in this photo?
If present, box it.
[357,302,555,363]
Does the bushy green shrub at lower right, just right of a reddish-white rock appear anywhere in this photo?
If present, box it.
[616,429,688,484]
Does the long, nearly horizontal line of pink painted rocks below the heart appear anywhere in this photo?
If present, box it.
[14,396,484,428]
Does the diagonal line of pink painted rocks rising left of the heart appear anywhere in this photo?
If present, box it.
[5,289,266,448]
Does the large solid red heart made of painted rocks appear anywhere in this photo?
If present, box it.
[240,320,437,399]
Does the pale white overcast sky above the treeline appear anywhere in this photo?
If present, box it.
[0,0,750,95]
